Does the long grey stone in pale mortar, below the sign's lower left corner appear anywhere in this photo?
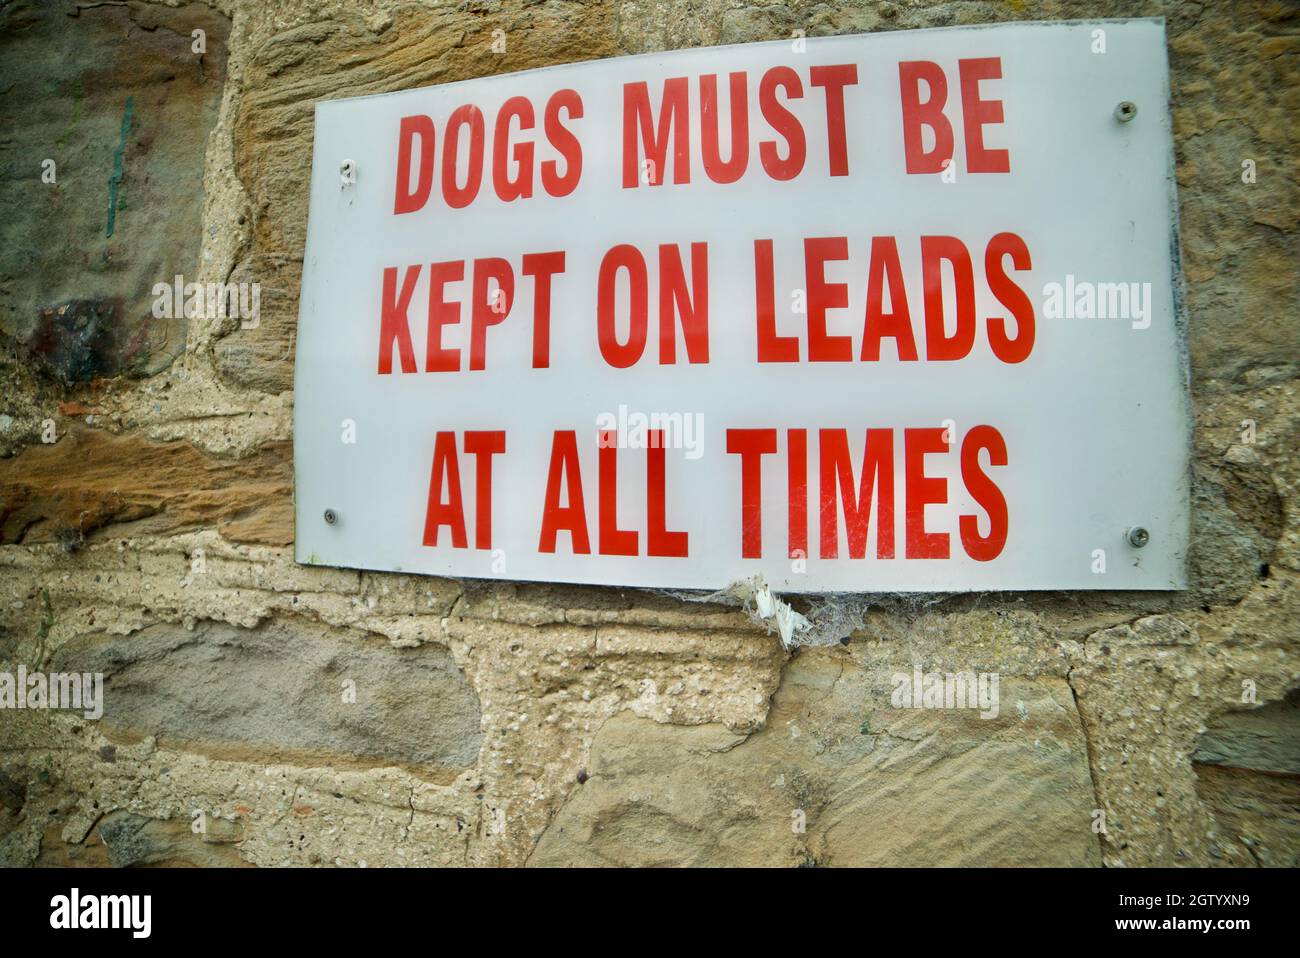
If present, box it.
[53,623,481,780]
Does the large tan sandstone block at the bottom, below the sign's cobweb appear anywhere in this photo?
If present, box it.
[529,651,1101,866]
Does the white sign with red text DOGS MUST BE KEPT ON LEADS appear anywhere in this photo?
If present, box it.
[294,21,1188,591]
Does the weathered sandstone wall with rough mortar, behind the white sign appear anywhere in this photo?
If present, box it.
[0,0,1300,866]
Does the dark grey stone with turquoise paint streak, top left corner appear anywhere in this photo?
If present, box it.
[0,0,230,385]
